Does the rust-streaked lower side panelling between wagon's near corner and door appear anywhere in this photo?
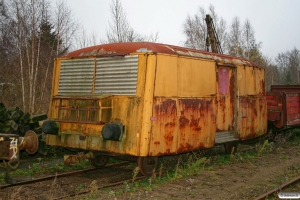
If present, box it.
[149,98,216,156]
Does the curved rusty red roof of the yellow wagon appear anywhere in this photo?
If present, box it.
[62,42,259,67]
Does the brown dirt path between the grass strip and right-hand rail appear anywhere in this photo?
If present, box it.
[116,146,300,200]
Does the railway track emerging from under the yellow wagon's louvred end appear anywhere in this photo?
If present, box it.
[0,161,145,199]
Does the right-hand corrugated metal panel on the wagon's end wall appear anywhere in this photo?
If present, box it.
[95,56,138,95]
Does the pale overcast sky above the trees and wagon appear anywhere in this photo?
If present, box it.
[67,0,300,58]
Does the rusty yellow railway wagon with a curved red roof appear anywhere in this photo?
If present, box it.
[42,42,267,175]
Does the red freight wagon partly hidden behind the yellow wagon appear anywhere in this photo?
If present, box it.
[266,85,300,129]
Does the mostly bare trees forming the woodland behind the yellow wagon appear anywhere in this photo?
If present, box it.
[0,0,300,114]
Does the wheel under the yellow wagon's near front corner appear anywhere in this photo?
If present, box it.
[137,156,158,176]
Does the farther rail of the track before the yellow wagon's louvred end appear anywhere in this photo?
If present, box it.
[0,161,129,189]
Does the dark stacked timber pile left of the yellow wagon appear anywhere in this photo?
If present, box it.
[0,102,47,136]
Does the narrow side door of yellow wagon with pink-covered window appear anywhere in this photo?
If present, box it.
[215,65,237,143]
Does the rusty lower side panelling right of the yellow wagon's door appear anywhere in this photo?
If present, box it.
[237,96,267,140]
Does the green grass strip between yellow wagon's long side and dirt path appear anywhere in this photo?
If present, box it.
[84,129,300,198]
